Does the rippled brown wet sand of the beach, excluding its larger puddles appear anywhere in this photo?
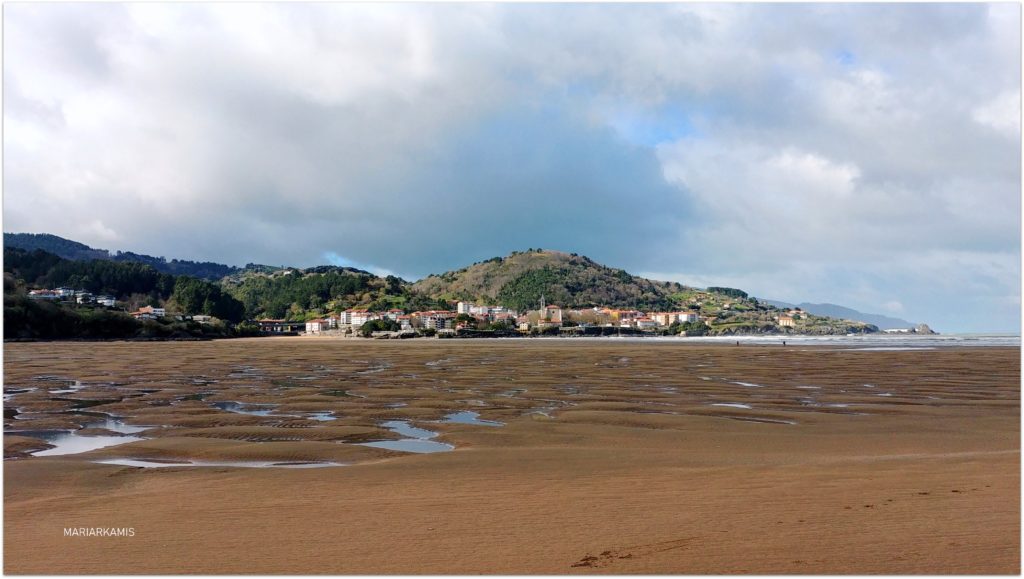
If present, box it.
[4,338,1020,574]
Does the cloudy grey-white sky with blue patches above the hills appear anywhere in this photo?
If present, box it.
[3,3,1021,332]
